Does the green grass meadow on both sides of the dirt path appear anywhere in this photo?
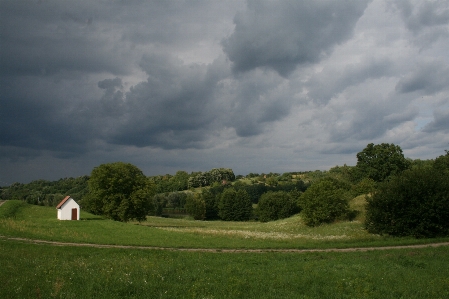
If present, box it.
[0,201,449,298]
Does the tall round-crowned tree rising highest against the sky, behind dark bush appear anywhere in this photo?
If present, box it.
[356,143,411,182]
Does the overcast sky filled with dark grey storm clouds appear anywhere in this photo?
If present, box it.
[0,0,449,186]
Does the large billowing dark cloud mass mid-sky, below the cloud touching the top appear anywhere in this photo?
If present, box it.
[108,55,292,149]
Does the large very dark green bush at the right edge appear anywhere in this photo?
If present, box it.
[365,168,449,237]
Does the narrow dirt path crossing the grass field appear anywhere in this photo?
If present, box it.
[0,235,449,253]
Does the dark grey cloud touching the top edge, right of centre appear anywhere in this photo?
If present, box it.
[223,0,369,76]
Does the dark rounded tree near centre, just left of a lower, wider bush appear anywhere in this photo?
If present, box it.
[218,188,253,221]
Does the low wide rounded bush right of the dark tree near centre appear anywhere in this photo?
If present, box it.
[258,191,299,222]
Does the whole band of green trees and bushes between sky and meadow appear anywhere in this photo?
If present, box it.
[0,143,449,237]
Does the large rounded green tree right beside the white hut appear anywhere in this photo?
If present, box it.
[82,162,152,222]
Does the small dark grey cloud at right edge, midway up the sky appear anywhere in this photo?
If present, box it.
[396,60,449,95]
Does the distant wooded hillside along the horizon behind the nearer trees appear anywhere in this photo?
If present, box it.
[0,159,434,207]
